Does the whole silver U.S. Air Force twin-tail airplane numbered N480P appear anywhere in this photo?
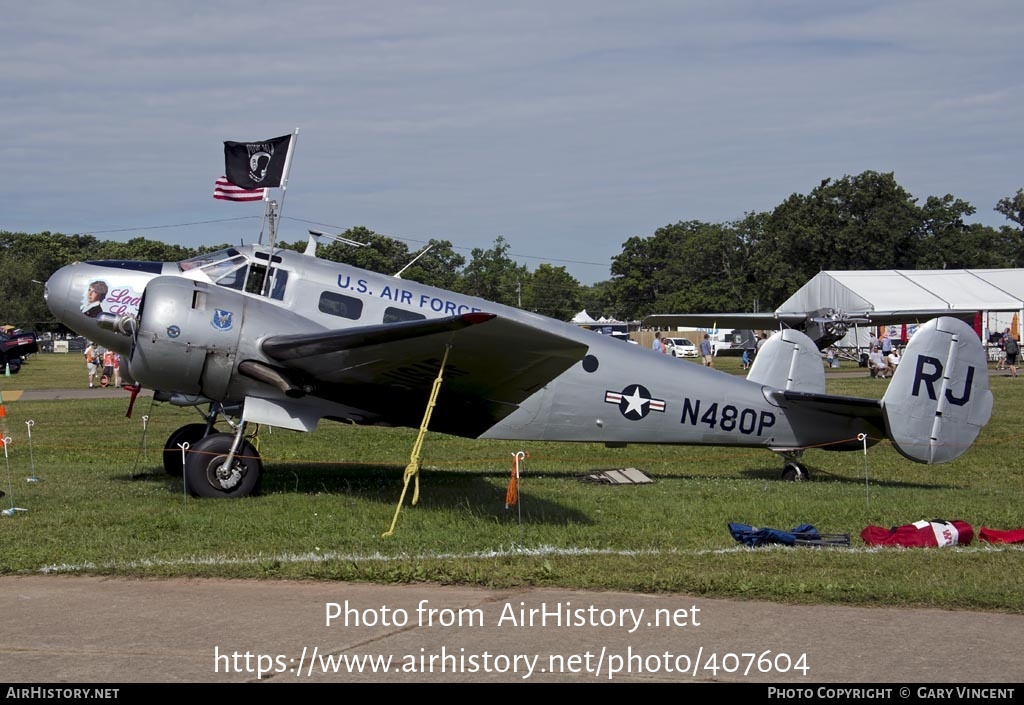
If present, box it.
[45,233,992,498]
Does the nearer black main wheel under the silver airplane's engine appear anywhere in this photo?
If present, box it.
[184,433,263,499]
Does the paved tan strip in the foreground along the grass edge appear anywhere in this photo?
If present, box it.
[0,576,1024,691]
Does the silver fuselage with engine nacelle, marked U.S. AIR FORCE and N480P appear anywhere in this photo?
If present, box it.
[47,245,878,449]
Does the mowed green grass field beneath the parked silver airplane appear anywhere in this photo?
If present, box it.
[0,354,1024,613]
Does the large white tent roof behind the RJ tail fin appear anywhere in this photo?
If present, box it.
[776,269,1024,345]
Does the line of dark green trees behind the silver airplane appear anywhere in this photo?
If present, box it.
[0,171,1024,331]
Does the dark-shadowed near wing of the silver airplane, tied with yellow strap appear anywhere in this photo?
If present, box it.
[261,314,588,438]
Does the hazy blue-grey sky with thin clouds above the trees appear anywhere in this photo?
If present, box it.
[0,0,1024,284]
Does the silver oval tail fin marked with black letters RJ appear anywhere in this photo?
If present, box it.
[882,317,992,463]
